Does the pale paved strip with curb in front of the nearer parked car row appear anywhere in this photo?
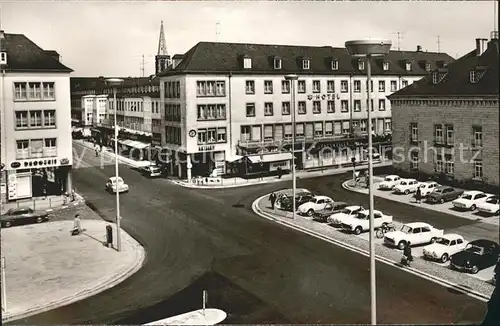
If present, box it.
[252,189,494,302]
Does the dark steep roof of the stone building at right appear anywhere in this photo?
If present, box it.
[388,39,499,99]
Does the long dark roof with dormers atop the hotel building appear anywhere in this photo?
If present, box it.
[159,42,454,76]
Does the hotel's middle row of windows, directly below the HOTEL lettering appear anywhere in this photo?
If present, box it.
[245,99,386,117]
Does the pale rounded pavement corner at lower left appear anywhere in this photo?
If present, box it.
[2,219,146,322]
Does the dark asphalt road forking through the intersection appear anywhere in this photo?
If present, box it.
[10,145,485,324]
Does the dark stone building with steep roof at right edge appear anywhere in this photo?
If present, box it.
[390,32,499,187]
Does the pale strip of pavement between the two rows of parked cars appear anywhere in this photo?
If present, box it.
[342,176,499,227]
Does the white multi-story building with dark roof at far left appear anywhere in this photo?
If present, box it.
[0,31,73,201]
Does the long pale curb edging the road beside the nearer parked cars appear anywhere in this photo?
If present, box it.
[252,194,490,302]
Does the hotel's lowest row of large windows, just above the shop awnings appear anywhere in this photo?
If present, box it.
[240,119,392,141]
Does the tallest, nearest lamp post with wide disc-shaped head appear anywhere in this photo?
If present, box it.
[345,39,391,325]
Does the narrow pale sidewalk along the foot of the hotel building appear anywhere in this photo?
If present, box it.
[169,161,392,189]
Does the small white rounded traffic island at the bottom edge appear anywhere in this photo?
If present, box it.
[145,308,227,325]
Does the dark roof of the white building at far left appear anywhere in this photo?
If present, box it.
[2,33,73,73]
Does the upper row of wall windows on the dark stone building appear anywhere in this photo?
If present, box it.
[410,122,483,147]
